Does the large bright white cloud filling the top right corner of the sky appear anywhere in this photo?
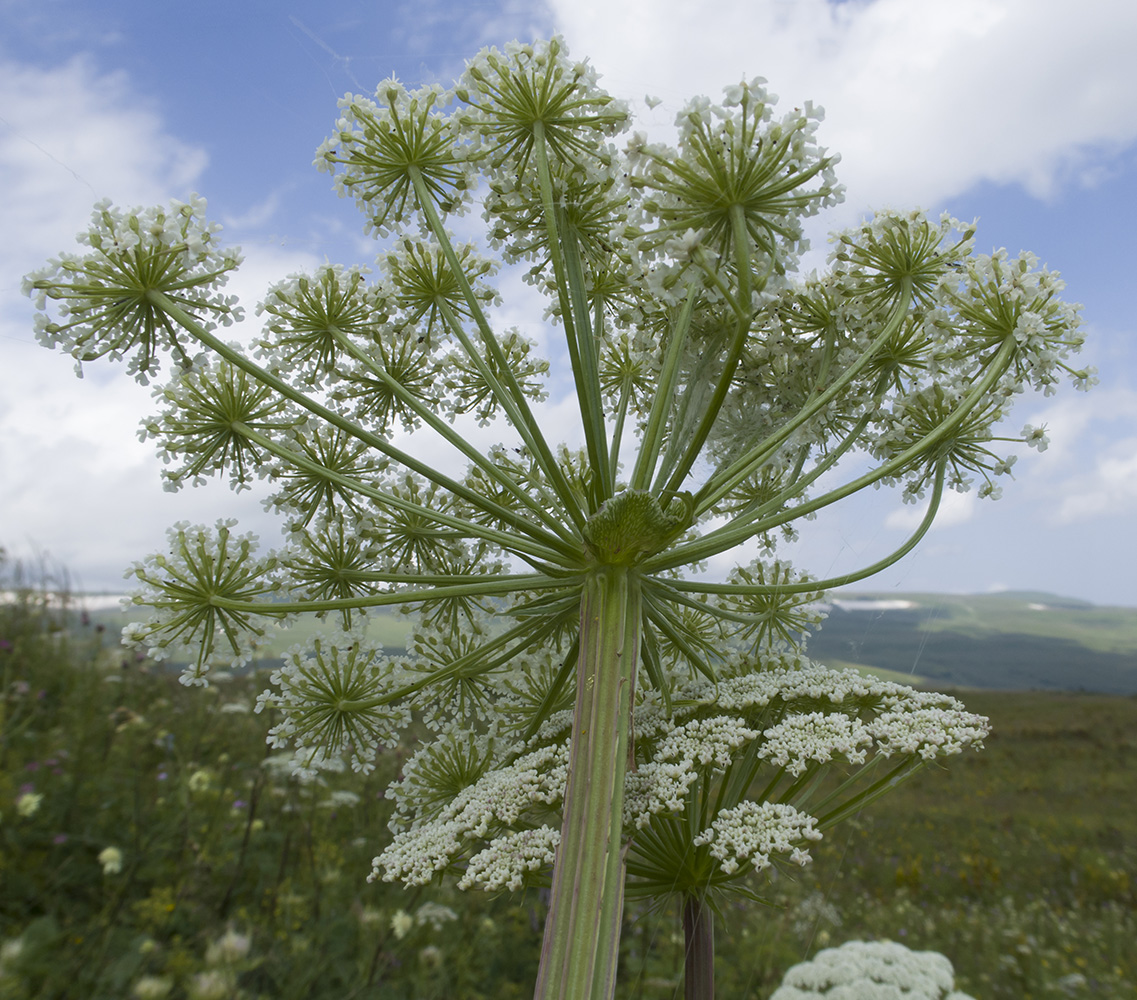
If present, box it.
[550,0,1137,214]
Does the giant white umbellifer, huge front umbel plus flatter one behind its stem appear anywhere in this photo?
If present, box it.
[26,39,1090,998]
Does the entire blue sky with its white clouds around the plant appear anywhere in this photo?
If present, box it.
[0,0,1137,606]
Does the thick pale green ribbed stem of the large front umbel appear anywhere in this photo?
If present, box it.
[534,566,640,1000]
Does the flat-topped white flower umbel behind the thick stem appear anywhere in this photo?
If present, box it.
[372,653,988,892]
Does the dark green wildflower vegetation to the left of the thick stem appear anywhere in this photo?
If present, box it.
[0,575,543,1000]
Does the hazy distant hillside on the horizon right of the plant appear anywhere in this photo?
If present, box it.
[808,591,1137,694]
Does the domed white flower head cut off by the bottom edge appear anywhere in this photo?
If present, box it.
[770,941,972,1000]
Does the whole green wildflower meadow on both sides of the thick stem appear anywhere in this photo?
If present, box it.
[0,591,1137,1000]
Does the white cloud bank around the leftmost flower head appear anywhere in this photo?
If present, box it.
[0,58,315,586]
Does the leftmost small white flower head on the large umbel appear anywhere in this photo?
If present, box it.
[23,197,241,384]
